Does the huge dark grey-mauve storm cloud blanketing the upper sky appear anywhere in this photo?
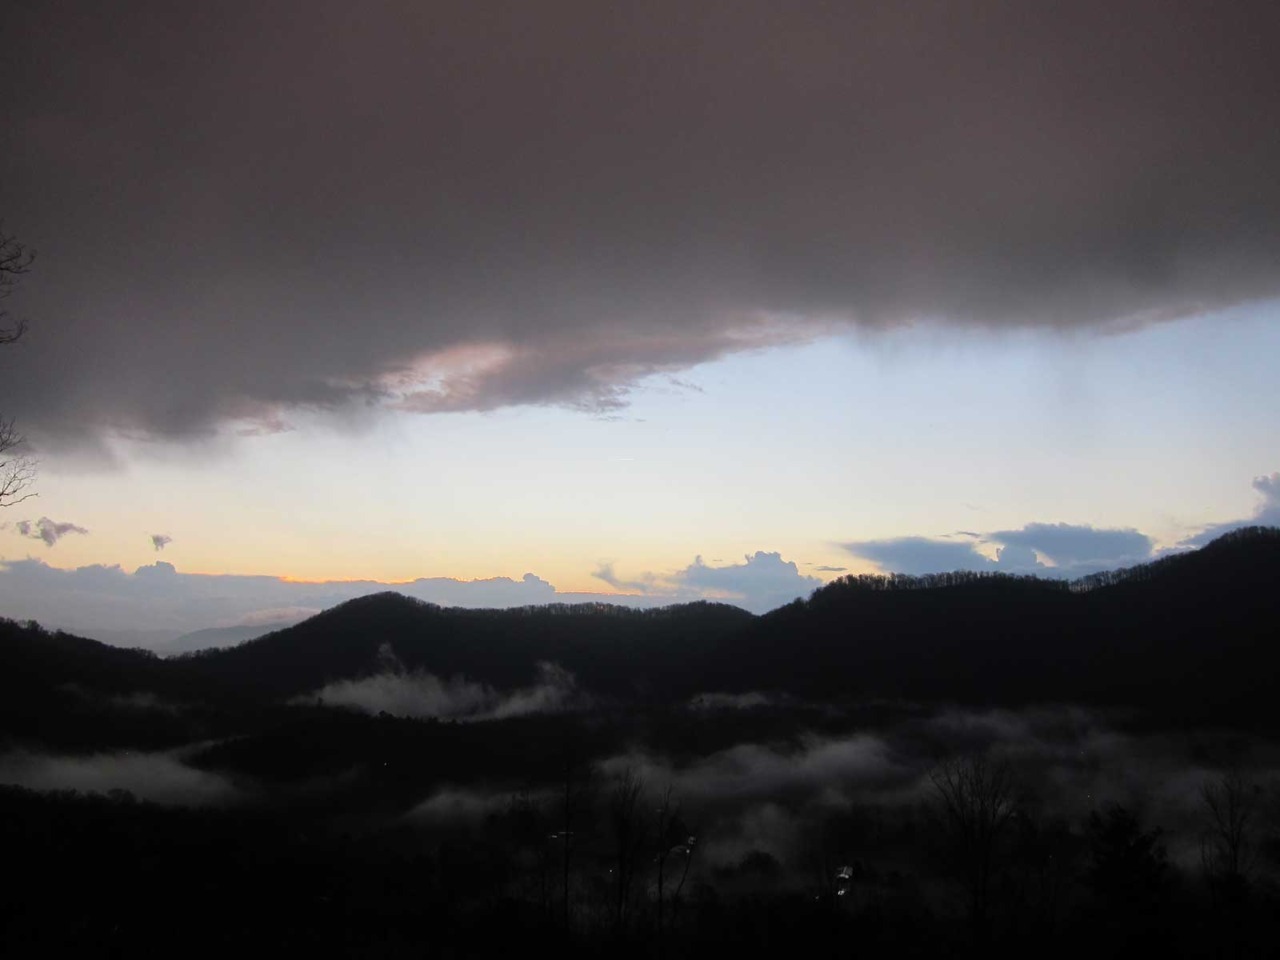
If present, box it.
[0,0,1280,445]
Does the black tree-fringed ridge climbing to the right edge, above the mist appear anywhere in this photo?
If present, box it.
[696,529,1280,727]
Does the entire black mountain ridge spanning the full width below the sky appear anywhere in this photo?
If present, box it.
[0,527,1280,742]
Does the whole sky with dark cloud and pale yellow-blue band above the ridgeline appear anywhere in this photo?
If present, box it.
[0,0,1280,636]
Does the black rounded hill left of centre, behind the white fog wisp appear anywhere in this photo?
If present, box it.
[174,591,753,698]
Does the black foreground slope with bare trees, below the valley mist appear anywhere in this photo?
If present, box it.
[0,754,1280,957]
